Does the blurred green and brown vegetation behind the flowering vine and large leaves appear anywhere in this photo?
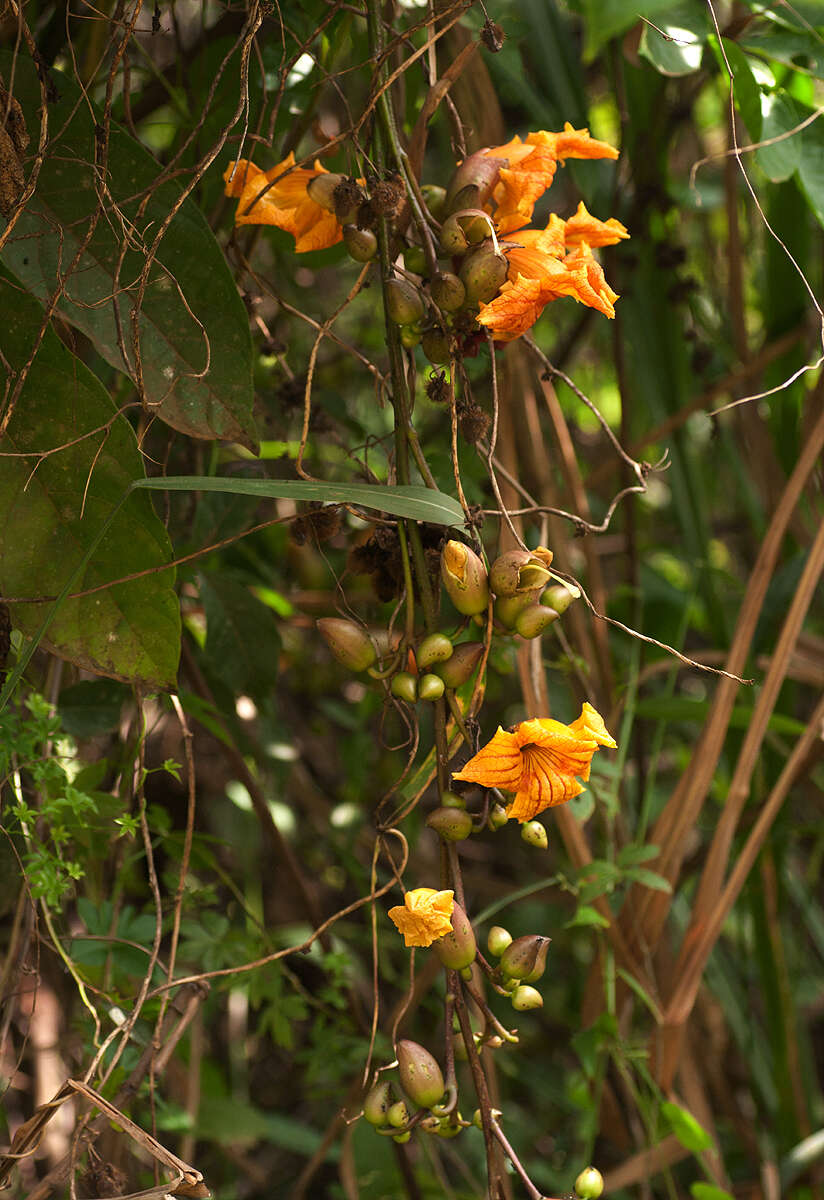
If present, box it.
[0,0,824,1200]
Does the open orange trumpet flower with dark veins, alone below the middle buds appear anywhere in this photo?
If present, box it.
[452,703,615,824]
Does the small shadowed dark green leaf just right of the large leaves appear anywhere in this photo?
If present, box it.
[200,575,281,700]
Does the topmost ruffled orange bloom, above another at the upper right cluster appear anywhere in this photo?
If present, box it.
[481,121,618,234]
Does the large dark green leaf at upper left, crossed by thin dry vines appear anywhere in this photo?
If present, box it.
[0,50,257,449]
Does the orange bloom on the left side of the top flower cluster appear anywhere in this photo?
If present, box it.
[223,154,343,254]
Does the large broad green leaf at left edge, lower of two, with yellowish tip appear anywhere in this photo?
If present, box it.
[0,276,180,689]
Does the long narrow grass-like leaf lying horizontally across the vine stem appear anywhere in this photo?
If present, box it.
[134,475,464,526]
